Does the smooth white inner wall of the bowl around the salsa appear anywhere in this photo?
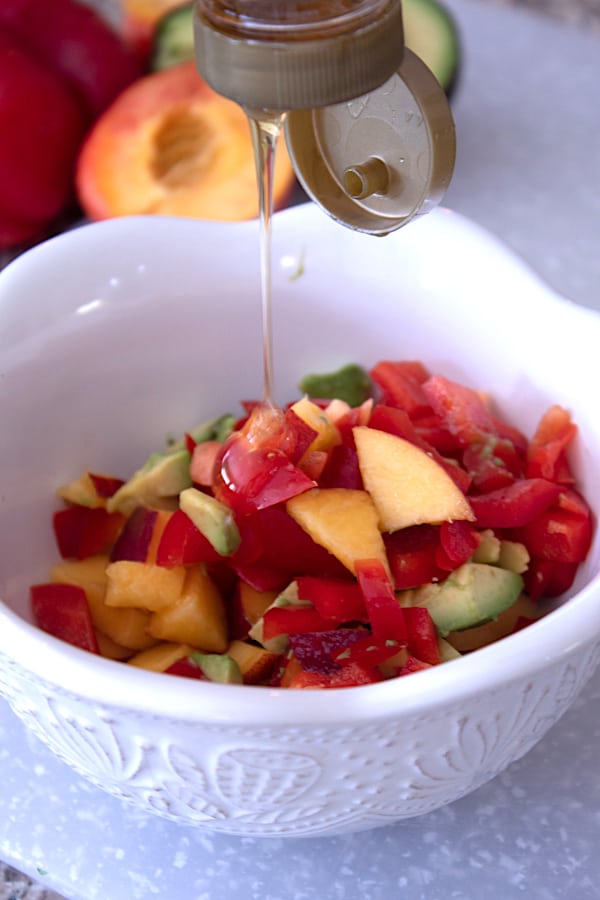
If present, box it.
[0,204,600,720]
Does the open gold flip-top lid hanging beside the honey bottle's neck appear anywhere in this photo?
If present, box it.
[285,49,456,235]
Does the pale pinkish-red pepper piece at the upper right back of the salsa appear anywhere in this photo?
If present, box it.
[423,375,496,447]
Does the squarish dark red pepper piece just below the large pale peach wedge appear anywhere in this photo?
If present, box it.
[383,525,447,590]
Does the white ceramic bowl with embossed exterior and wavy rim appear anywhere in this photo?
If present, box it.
[0,206,600,835]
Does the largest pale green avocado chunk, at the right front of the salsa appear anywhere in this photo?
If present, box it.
[398,562,523,637]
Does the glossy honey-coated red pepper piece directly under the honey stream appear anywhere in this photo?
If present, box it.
[214,434,316,514]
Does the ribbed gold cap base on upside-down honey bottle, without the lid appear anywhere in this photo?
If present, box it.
[194,0,404,112]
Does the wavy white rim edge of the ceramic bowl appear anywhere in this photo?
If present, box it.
[0,203,600,726]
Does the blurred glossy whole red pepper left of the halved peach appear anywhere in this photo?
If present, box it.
[0,0,141,250]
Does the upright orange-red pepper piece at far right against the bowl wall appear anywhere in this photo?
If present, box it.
[527,405,577,484]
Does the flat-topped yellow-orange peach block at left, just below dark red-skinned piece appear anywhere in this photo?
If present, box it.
[105,560,186,612]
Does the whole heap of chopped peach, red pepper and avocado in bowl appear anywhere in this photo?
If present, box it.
[31,360,592,688]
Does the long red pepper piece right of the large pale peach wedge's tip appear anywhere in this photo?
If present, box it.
[469,478,560,528]
